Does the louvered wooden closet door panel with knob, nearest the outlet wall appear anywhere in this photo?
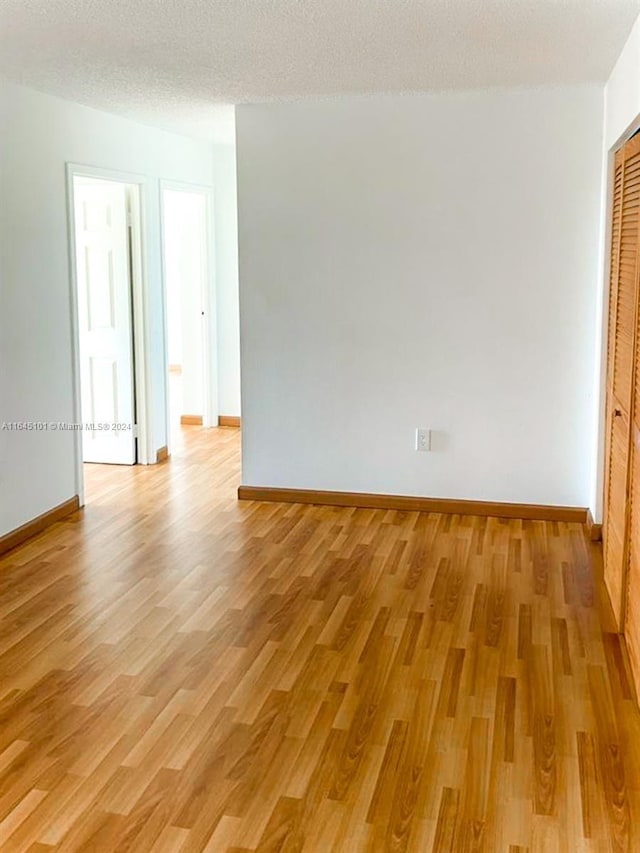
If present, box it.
[604,137,640,627]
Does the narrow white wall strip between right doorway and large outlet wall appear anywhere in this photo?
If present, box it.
[213,142,240,415]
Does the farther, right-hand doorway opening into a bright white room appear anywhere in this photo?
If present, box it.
[161,182,214,447]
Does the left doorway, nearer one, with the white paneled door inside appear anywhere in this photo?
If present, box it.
[67,165,148,503]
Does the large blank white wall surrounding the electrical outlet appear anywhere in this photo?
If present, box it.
[236,87,603,506]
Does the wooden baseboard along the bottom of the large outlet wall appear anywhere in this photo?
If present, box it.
[238,486,587,524]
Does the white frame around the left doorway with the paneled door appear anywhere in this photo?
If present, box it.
[66,163,155,506]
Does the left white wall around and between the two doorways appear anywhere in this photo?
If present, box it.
[0,82,213,535]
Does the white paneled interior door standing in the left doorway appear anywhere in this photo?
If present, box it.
[74,179,136,465]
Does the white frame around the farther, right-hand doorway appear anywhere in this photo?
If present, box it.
[160,179,219,453]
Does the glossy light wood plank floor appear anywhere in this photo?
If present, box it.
[0,427,640,853]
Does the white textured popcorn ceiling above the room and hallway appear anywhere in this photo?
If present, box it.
[0,0,640,138]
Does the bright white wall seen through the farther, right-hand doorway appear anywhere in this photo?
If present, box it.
[163,190,207,415]
